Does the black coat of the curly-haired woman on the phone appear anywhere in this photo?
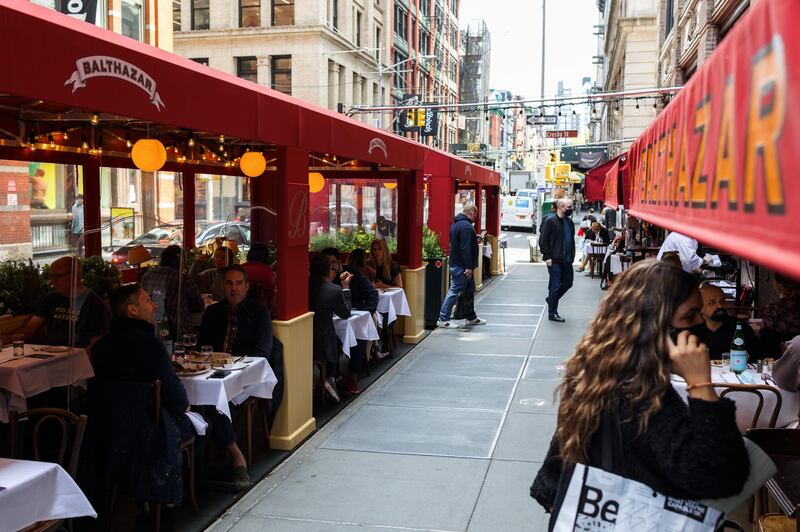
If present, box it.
[530,388,750,511]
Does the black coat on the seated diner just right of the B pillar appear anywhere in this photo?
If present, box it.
[308,279,353,362]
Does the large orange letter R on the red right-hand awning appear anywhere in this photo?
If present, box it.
[743,35,786,214]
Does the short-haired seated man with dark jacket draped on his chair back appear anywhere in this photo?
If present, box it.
[92,284,250,490]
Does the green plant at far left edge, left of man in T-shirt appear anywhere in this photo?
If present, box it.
[0,259,49,315]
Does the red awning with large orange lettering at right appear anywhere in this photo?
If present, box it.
[629,0,800,278]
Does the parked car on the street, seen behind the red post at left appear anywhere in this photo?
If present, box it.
[111,221,250,270]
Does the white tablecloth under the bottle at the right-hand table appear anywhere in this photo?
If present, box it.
[672,366,800,433]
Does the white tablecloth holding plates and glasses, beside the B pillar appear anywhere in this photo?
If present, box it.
[181,357,278,418]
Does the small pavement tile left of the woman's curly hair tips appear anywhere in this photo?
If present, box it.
[492,412,557,462]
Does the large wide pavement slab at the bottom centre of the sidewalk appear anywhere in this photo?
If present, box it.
[251,450,489,530]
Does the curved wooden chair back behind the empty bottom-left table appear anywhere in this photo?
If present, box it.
[9,408,88,478]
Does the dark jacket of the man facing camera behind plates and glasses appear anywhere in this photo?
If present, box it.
[197,296,272,357]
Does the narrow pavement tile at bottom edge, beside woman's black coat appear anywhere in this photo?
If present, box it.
[467,461,550,532]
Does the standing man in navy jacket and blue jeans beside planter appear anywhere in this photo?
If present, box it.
[436,203,486,328]
